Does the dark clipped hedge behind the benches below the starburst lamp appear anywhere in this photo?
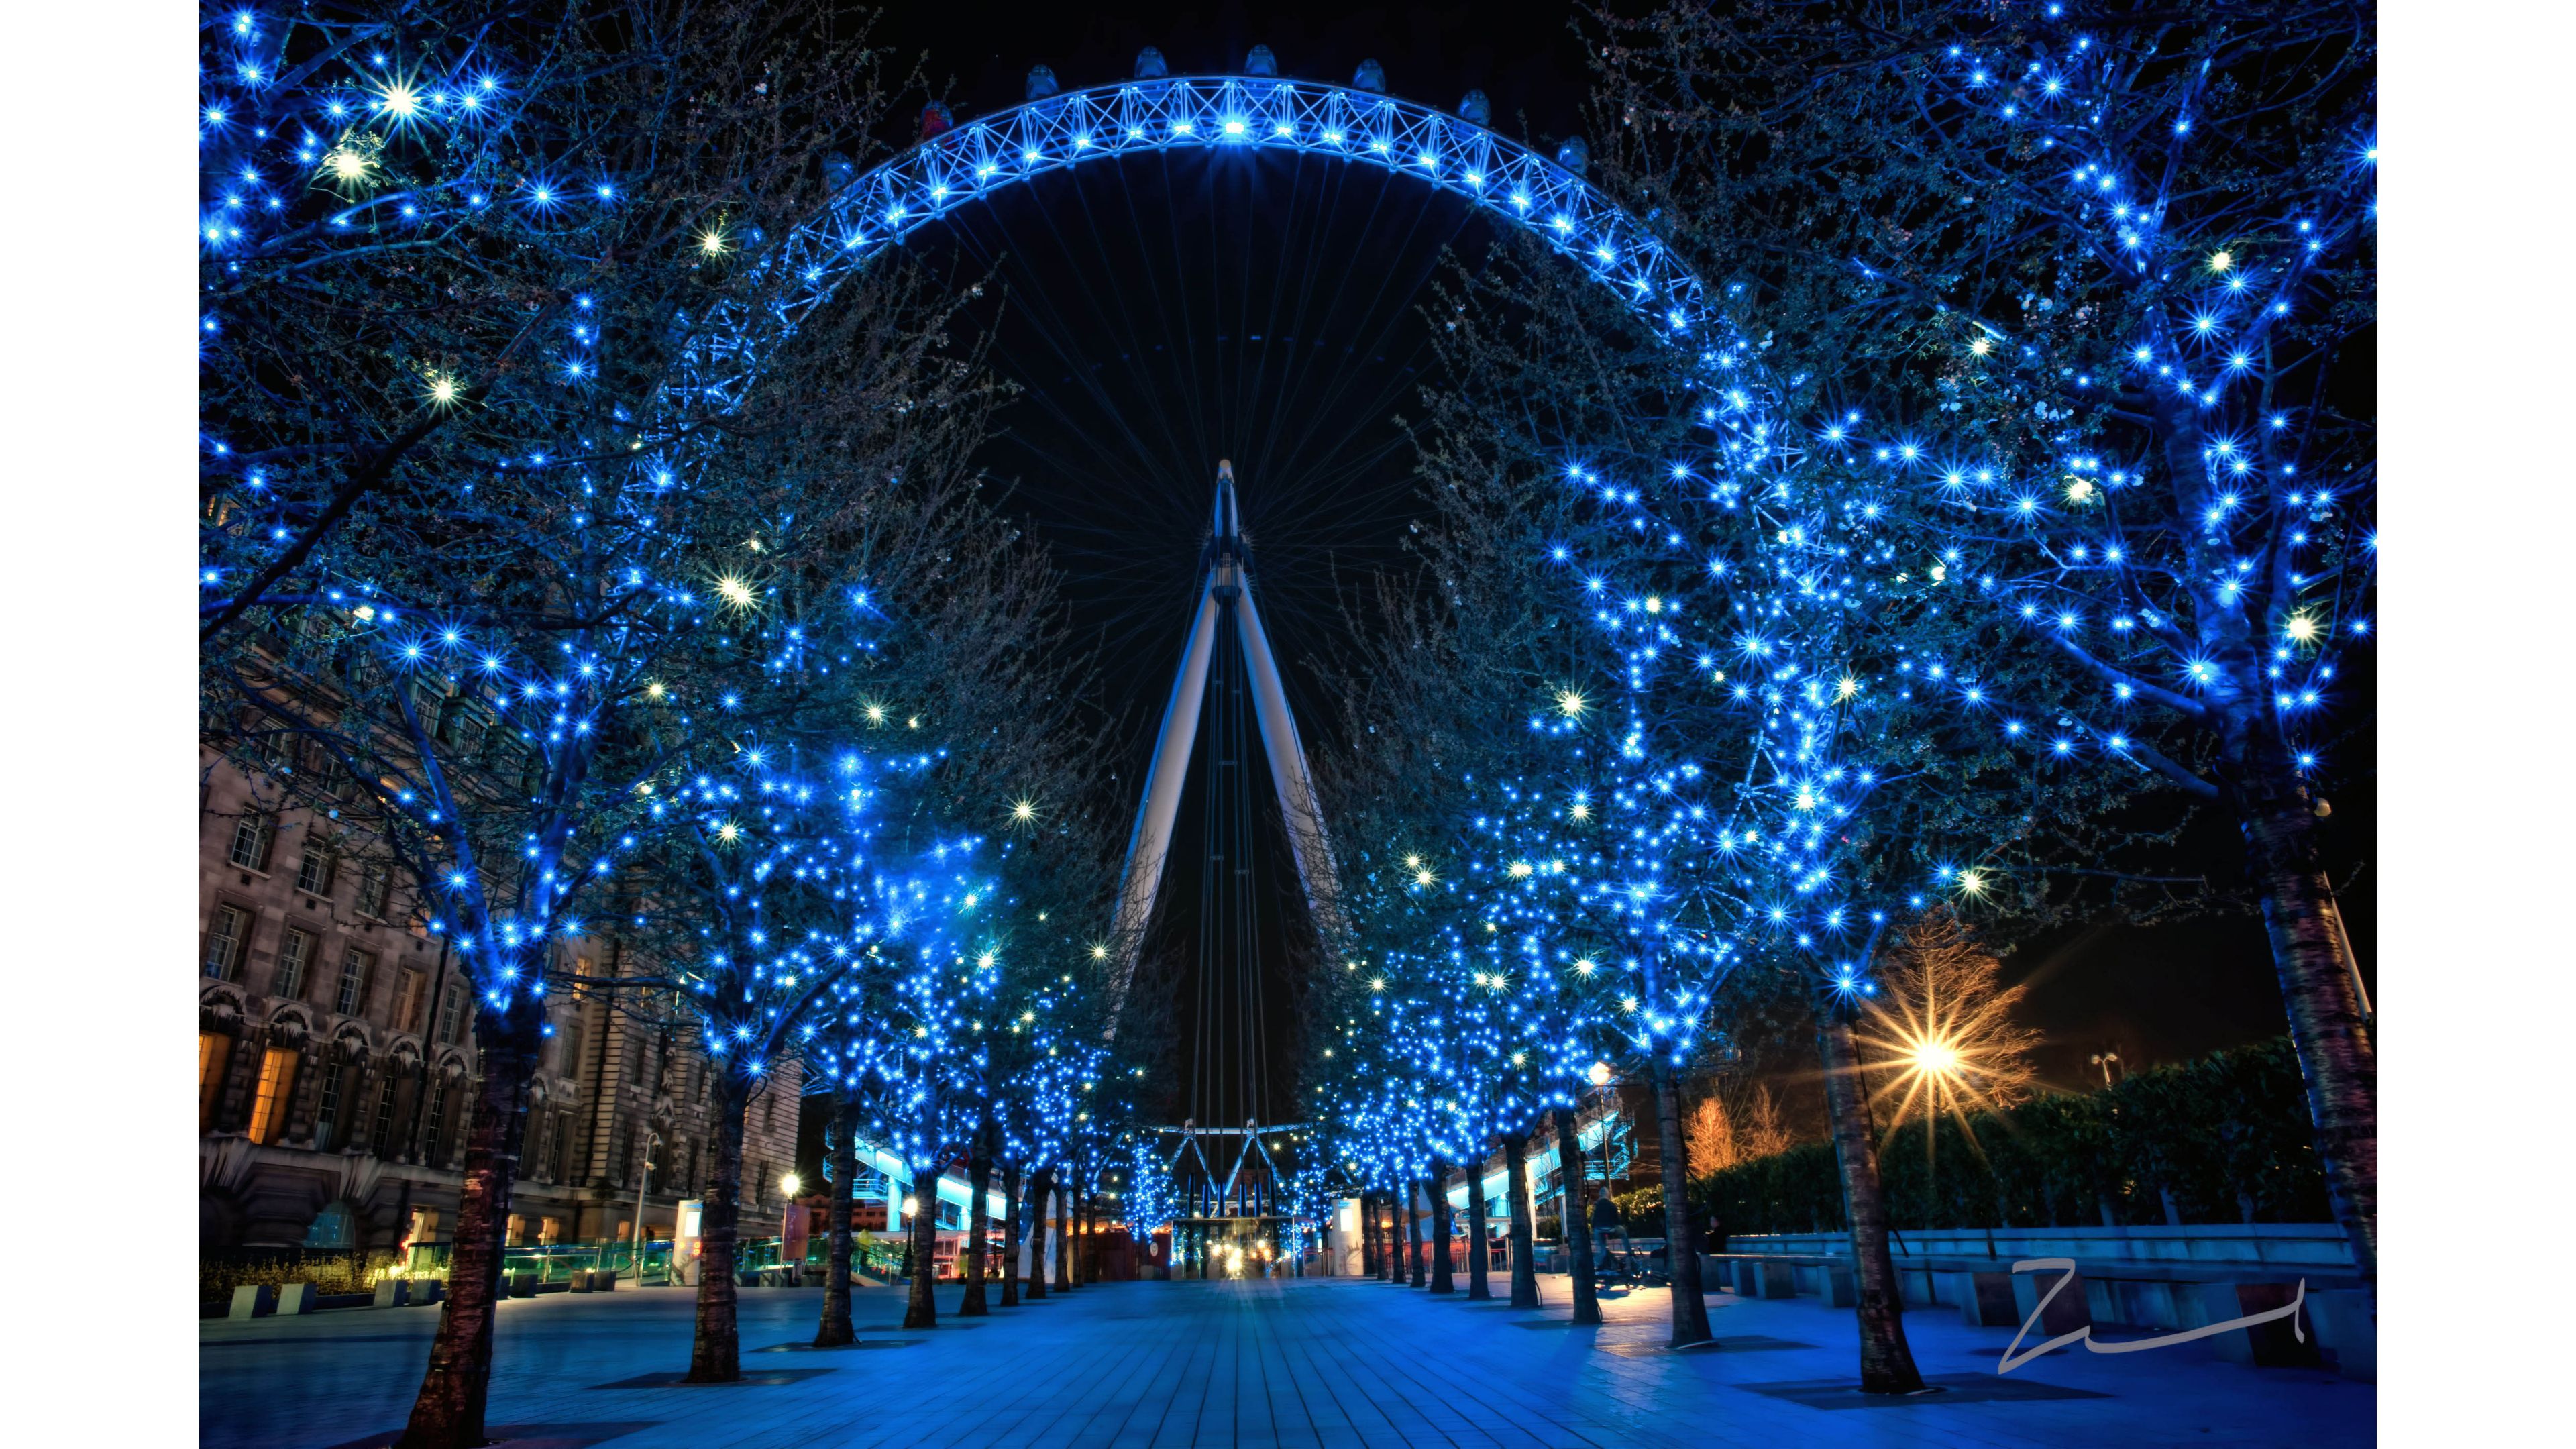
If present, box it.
[1679,1036,2331,1235]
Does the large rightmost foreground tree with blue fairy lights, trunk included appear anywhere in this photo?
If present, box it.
[1597,0,2377,1279]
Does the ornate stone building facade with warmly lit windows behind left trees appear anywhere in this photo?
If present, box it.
[199,755,801,1248]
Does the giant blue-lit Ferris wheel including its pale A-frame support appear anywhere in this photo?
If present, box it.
[683,46,1754,1122]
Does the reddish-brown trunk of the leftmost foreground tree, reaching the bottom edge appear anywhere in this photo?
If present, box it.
[386,1036,536,1449]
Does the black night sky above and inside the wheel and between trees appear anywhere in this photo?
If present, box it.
[829,3,2377,1119]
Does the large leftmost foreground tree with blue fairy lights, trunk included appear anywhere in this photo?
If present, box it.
[199,5,1056,1446]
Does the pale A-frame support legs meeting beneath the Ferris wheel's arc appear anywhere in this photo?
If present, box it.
[1110,462,1342,1034]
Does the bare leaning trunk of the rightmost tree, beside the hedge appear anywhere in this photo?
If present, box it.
[2231,763,2380,1279]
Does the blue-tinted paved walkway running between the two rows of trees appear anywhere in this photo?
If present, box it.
[199,1279,2375,1449]
